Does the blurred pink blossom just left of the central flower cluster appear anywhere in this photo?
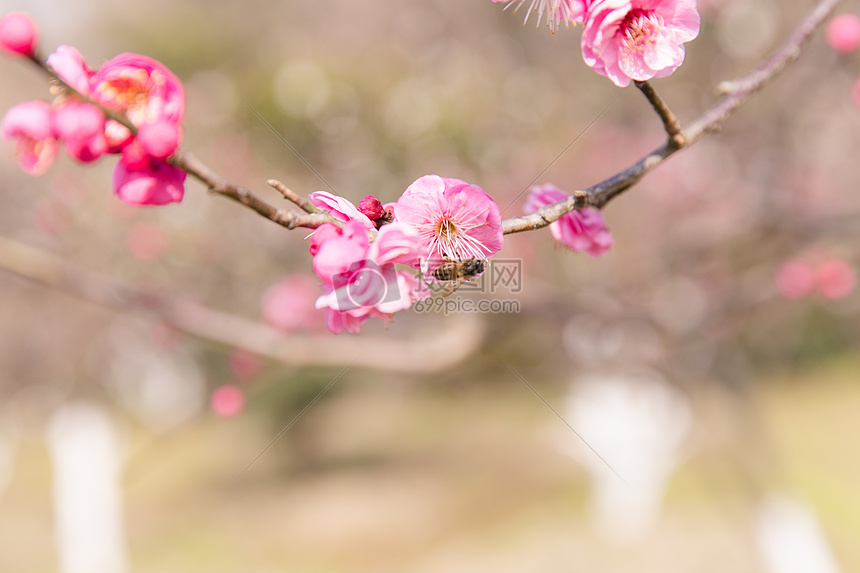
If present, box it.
[262,272,322,333]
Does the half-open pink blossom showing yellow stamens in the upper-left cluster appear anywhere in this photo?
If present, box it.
[90,53,185,127]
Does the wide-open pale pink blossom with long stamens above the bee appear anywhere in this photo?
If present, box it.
[392,175,504,261]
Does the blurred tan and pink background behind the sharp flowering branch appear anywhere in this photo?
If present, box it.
[0,0,860,573]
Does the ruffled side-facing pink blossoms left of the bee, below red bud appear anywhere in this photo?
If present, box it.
[313,220,429,333]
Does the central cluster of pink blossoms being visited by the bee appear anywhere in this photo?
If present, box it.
[309,175,503,333]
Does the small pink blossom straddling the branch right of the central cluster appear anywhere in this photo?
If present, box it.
[523,184,615,257]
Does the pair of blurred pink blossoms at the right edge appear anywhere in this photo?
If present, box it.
[774,254,857,300]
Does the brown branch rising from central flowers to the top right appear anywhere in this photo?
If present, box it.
[502,0,841,234]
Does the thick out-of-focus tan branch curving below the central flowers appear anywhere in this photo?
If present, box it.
[0,236,484,373]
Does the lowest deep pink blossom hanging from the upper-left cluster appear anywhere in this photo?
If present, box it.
[113,156,186,205]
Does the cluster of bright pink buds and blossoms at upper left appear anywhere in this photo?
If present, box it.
[0,13,186,205]
